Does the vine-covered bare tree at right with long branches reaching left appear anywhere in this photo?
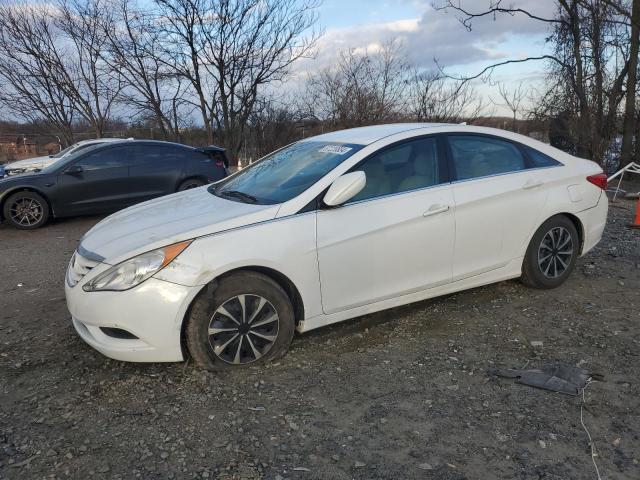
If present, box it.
[437,0,630,165]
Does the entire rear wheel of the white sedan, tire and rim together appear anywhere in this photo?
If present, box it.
[521,215,580,289]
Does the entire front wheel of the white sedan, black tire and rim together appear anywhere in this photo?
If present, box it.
[185,272,295,371]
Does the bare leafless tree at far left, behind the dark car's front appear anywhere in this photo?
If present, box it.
[0,0,121,141]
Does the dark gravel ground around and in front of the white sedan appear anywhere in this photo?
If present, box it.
[0,191,640,480]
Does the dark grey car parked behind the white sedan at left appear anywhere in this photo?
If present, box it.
[0,140,228,229]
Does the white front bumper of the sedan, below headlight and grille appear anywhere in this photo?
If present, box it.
[65,278,199,362]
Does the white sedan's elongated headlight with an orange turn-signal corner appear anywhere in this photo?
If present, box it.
[82,240,191,292]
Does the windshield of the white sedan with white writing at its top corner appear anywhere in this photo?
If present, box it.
[214,141,363,205]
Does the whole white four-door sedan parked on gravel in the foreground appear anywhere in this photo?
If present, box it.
[65,124,607,369]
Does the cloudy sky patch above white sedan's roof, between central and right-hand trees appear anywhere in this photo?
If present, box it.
[296,0,555,114]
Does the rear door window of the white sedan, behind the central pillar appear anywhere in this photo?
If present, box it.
[448,135,527,180]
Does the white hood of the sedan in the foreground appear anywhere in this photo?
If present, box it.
[80,187,279,264]
